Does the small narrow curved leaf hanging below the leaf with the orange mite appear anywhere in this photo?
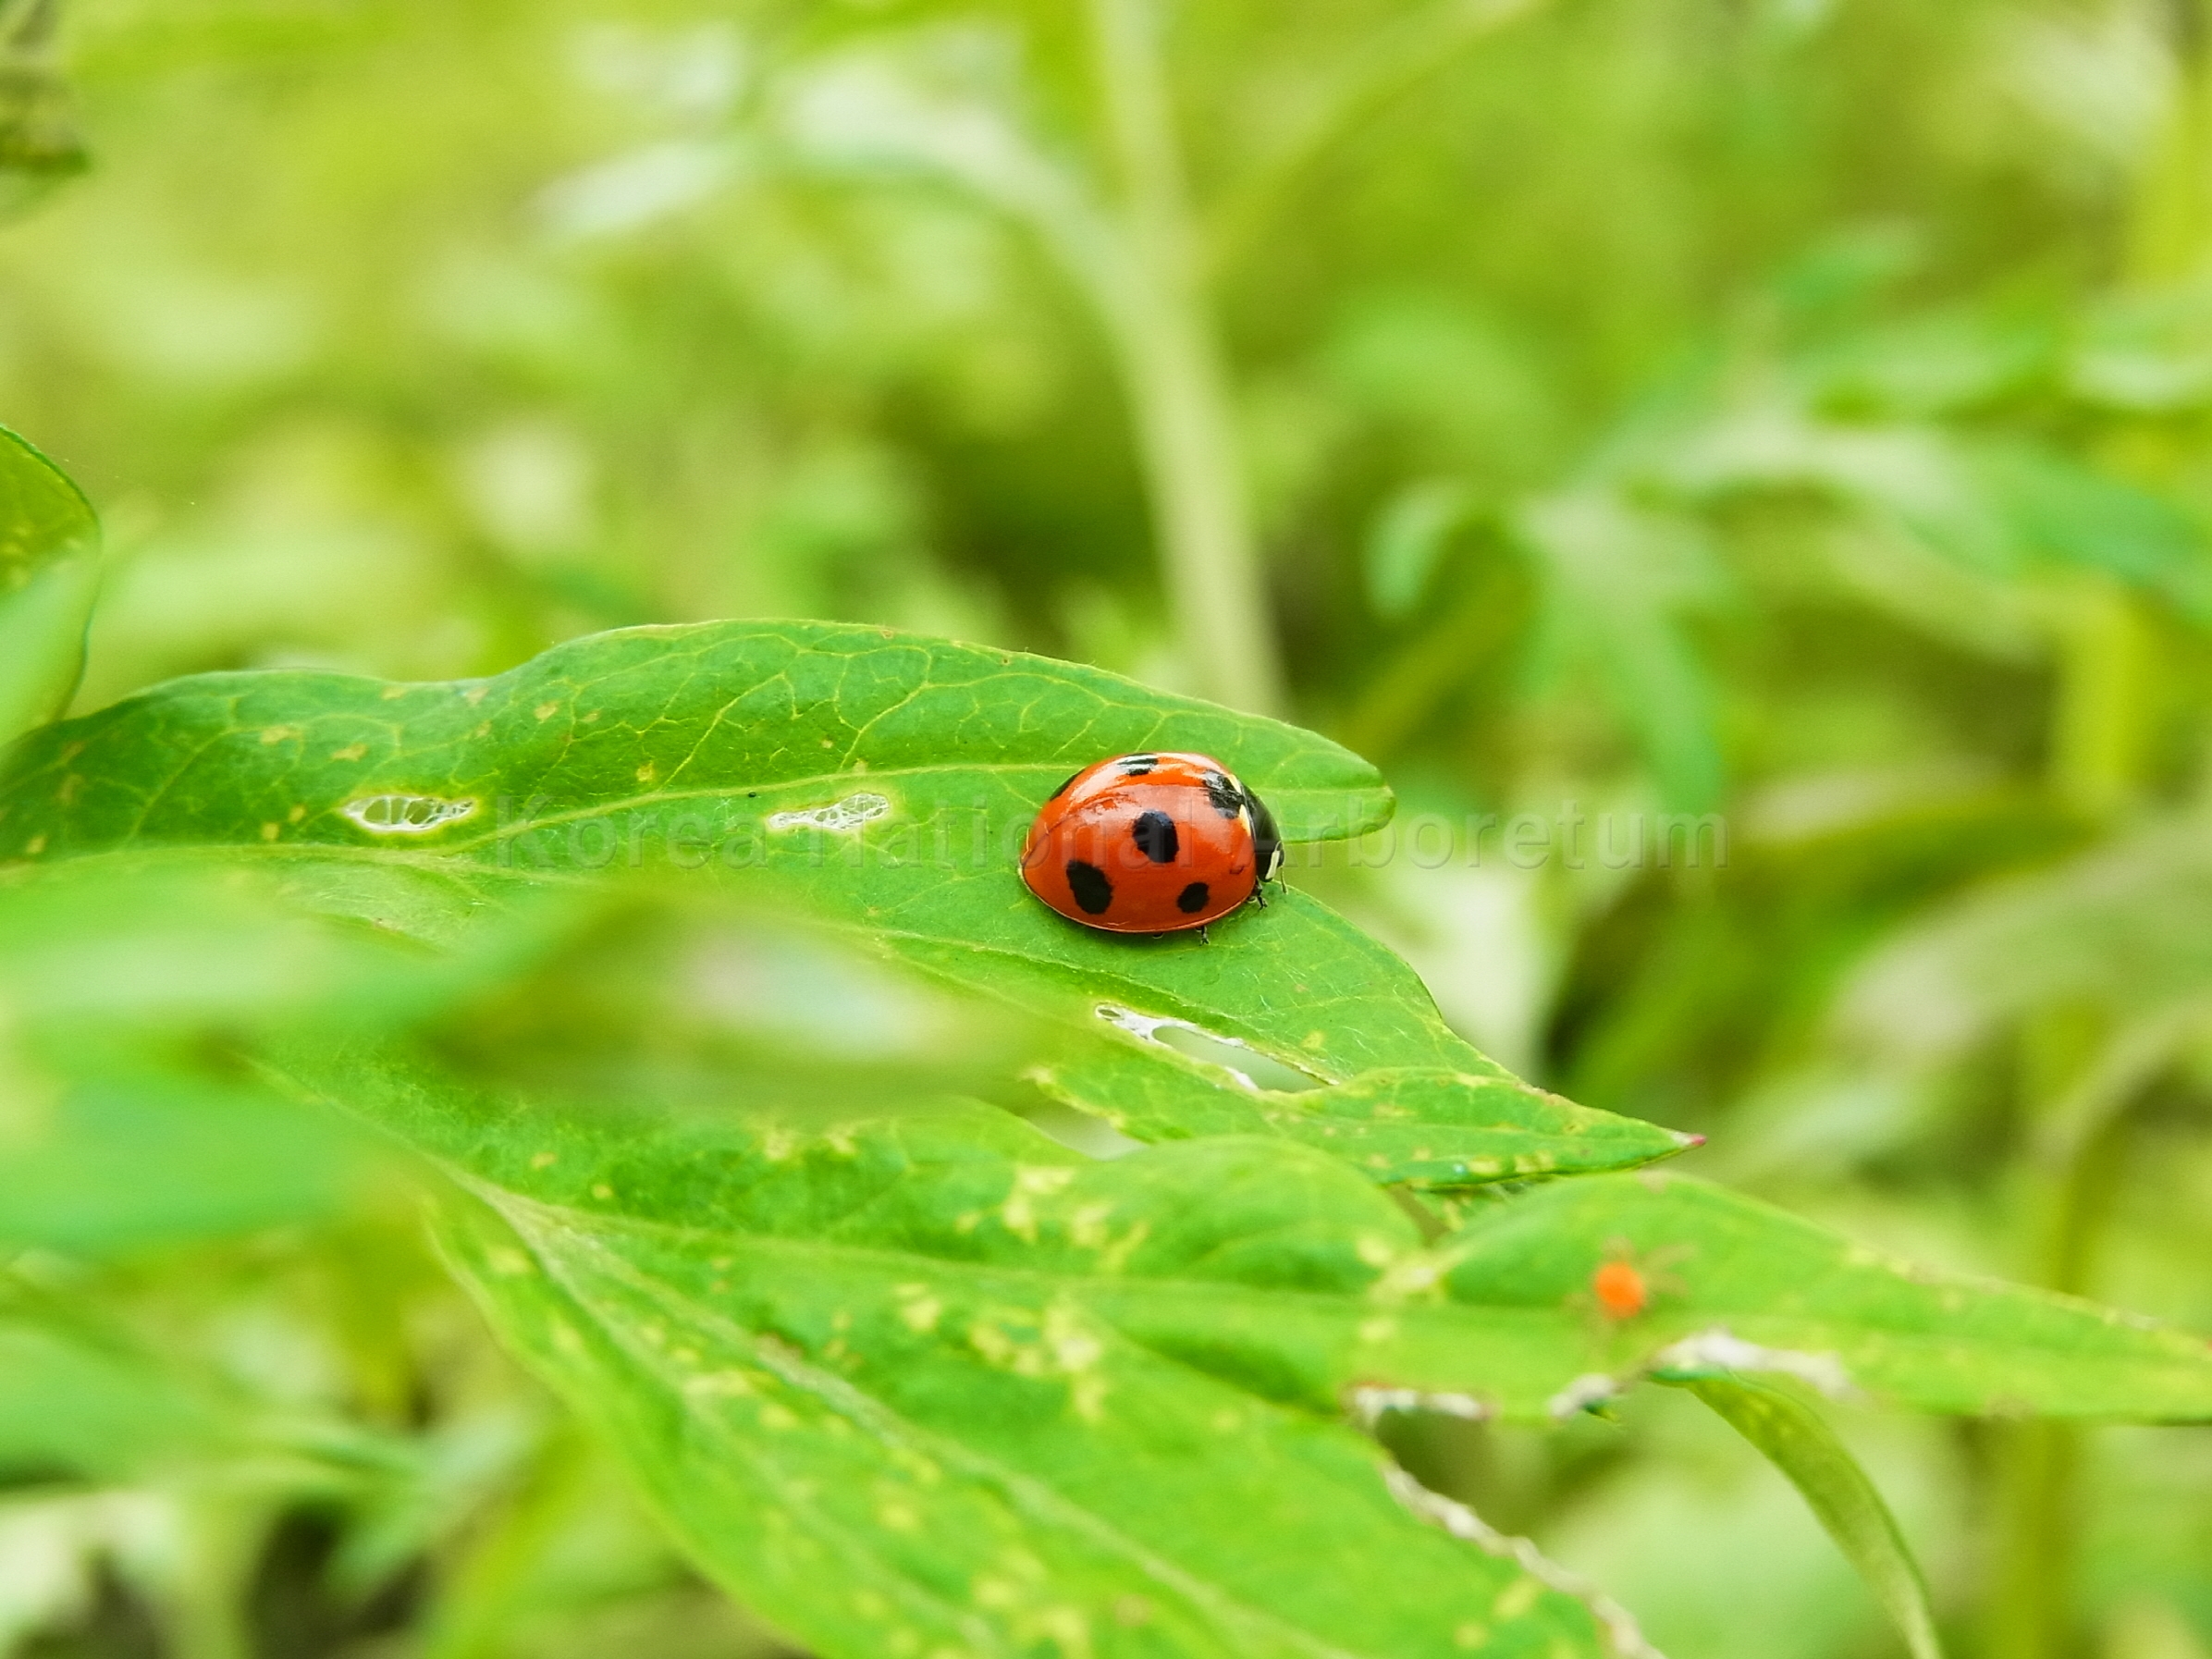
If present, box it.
[1686,1376,1942,1659]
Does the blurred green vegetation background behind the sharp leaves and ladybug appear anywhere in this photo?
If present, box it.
[0,0,2212,1659]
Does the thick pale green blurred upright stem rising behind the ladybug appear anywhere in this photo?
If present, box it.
[1090,0,1283,715]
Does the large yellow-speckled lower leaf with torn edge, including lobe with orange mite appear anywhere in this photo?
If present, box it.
[267,1008,2212,1654]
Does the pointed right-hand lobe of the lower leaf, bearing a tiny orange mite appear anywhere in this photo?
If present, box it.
[1424,1173,2212,1422]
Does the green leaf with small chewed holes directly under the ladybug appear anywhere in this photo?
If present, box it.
[0,621,1688,1186]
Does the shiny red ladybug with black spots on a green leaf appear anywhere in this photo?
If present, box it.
[1022,750,1283,940]
